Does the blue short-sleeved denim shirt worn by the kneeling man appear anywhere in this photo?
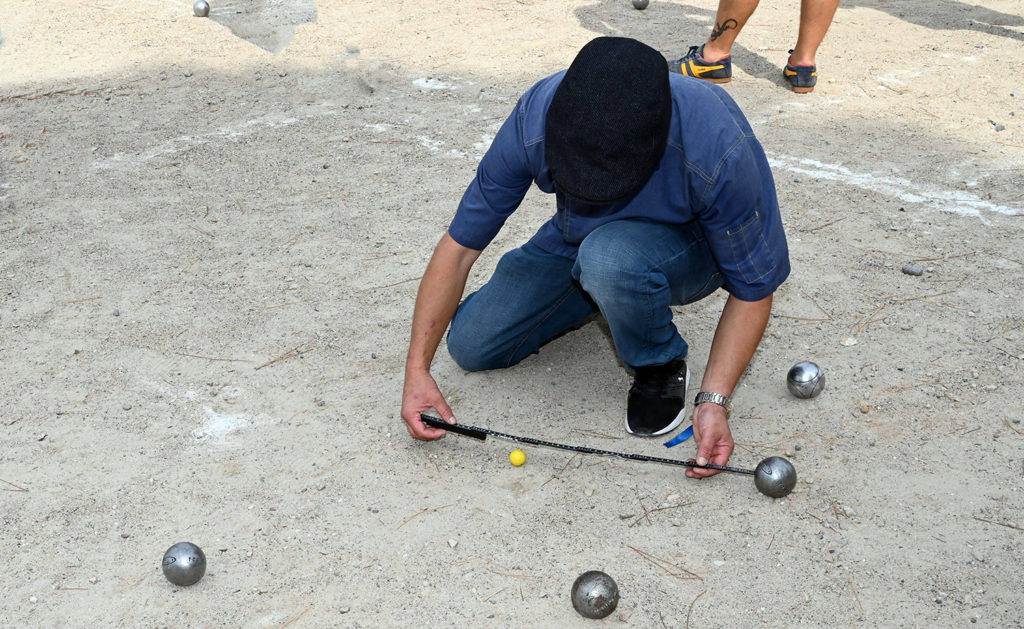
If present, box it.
[449,71,790,301]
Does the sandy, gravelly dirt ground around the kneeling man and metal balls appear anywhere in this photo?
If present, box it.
[0,0,1024,629]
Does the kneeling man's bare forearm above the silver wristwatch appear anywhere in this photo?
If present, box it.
[700,295,772,396]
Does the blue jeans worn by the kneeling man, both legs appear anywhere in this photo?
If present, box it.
[447,219,722,371]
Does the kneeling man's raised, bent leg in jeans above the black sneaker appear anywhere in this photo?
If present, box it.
[572,220,722,368]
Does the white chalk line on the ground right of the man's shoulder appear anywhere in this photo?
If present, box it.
[768,154,1024,218]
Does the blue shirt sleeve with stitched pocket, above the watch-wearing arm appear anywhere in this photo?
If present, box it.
[698,135,790,301]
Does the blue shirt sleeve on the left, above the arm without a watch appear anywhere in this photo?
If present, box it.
[449,99,535,251]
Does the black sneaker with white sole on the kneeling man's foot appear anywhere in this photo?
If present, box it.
[626,361,690,436]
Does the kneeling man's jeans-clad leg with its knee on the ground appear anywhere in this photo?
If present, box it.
[447,243,597,371]
